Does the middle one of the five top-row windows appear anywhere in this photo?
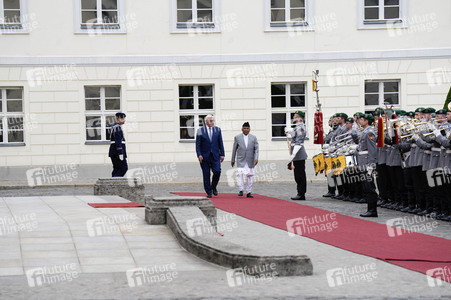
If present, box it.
[172,0,220,33]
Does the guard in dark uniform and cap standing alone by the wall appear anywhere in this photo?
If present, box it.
[108,112,128,177]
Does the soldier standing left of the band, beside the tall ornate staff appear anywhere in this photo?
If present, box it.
[290,111,307,200]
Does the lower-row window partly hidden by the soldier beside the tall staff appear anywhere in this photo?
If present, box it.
[271,83,307,138]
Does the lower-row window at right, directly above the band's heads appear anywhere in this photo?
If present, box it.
[365,80,399,112]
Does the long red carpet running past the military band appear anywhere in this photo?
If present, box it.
[175,192,451,282]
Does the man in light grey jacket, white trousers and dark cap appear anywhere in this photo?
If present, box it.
[232,122,258,198]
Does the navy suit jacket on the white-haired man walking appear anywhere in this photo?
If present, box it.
[196,126,225,160]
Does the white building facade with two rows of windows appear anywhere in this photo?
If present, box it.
[0,0,451,185]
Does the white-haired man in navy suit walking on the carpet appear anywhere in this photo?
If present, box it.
[196,115,225,198]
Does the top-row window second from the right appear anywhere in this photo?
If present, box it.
[265,0,314,31]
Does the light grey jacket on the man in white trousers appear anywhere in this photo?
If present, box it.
[232,133,258,168]
